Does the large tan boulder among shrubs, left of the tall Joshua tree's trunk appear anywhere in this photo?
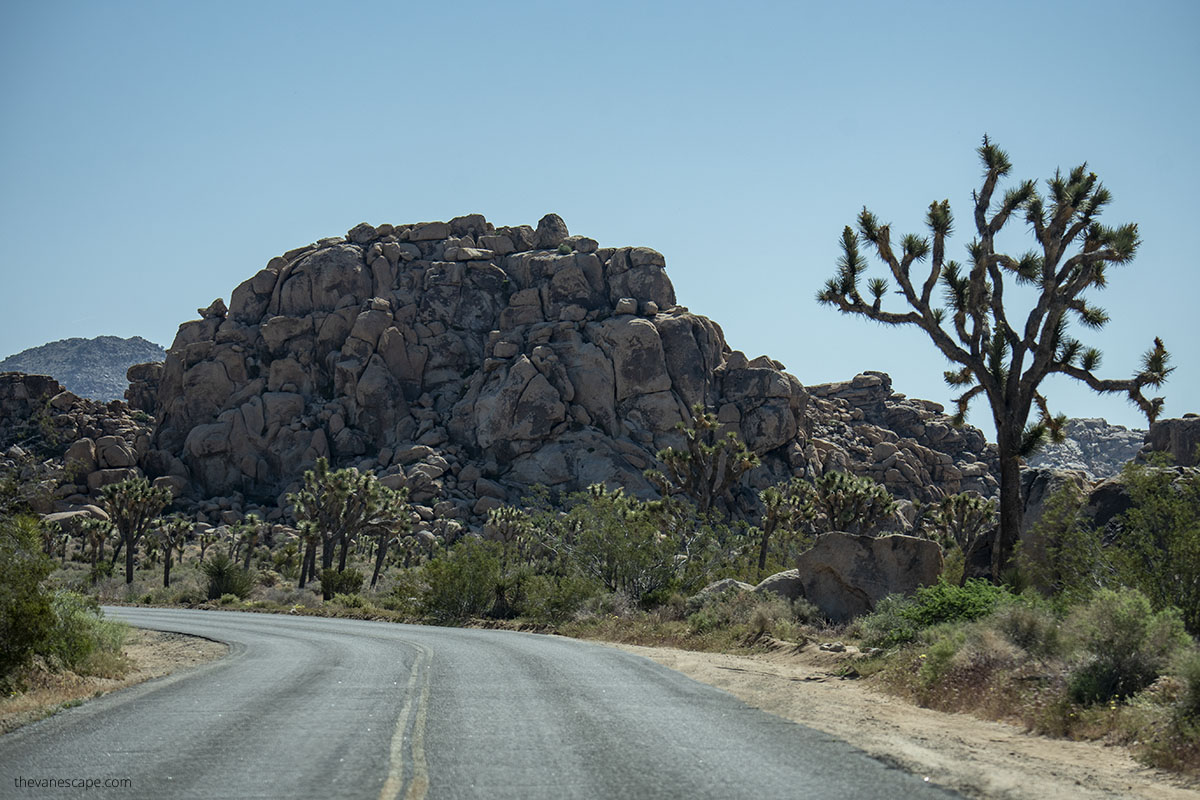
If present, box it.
[796,533,942,622]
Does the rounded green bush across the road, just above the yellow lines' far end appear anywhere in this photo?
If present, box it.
[421,539,500,622]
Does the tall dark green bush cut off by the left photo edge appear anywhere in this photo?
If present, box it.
[0,517,55,688]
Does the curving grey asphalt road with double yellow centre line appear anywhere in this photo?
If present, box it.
[0,608,955,800]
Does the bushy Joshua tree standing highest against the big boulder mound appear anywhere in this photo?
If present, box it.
[646,404,758,513]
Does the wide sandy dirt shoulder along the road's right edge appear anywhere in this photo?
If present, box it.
[612,644,1200,800]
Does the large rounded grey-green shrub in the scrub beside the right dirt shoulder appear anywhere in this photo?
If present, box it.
[1068,589,1190,705]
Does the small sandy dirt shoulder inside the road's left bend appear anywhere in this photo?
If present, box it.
[0,628,229,734]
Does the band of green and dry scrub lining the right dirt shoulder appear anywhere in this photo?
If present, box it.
[851,582,1200,774]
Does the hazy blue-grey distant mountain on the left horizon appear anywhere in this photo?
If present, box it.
[0,336,167,402]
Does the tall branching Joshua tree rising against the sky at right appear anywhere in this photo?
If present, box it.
[817,137,1171,579]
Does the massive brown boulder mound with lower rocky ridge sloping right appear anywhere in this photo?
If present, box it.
[130,215,995,525]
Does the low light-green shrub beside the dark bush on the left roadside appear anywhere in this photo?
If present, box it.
[41,591,127,674]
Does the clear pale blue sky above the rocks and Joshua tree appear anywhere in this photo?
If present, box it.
[0,0,1200,438]
